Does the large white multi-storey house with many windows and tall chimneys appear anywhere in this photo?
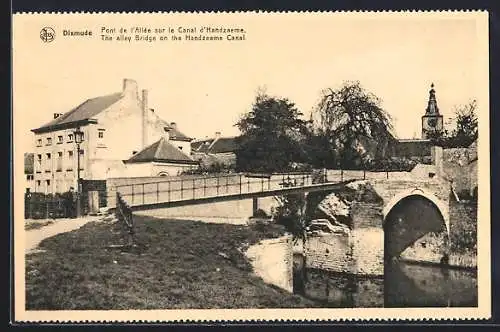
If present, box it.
[32,79,195,193]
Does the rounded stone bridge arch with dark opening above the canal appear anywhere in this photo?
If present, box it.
[382,188,449,258]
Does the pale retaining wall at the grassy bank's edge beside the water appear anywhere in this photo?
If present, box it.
[245,235,293,292]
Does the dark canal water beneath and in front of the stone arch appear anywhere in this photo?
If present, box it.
[294,255,478,308]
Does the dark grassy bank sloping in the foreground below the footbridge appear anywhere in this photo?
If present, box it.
[26,216,315,310]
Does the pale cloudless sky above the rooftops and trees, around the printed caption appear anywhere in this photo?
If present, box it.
[13,14,488,149]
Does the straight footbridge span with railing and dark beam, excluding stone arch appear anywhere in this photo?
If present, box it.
[112,173,354,211]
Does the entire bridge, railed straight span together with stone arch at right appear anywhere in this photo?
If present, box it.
[108,165,450,274]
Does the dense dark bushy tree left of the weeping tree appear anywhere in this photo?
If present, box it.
[236,91,307,172]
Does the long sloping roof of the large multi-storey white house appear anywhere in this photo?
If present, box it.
[32,92,122,133]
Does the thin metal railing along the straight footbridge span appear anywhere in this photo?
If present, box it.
[116,173,316,206]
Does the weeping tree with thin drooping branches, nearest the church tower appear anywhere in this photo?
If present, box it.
[312,81,393,168]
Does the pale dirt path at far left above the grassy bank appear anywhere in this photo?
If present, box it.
[24,217,103,254]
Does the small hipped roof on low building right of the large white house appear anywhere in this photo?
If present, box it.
[125,137,198,165]
